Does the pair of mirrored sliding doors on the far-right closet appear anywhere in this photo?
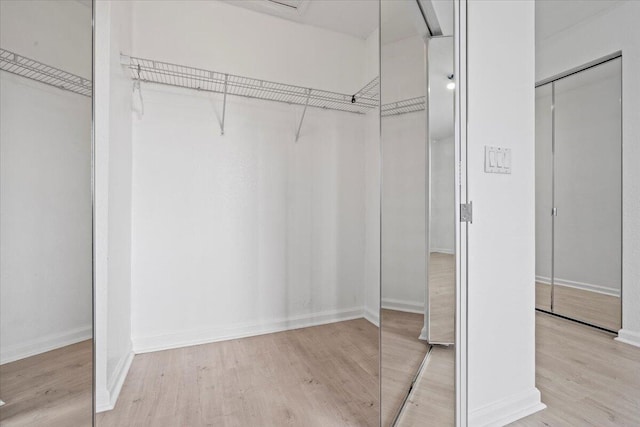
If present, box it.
[536,56,622,332]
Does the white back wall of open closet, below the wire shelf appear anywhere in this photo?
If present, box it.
[133,85,365,352]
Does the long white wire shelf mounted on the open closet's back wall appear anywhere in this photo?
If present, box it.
[125,57,380,114]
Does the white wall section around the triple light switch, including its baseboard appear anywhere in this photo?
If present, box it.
[467,1,543,426]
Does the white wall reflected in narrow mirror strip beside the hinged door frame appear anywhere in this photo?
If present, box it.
[429,136,455,254]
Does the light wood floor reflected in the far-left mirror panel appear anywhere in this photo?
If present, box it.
[0,341,93,427]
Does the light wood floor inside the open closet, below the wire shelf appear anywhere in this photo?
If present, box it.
[97,319,379,427]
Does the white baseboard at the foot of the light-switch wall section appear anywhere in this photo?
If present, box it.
[469,387,547,427]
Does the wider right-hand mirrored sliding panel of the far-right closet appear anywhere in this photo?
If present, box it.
[553,58,622,330]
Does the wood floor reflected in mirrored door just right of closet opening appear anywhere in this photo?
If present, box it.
[381,310,429,426]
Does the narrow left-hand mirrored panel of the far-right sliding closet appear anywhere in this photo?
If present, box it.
[536,83,553,311]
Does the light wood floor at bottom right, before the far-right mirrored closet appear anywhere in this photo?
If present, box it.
[513,313,640,427]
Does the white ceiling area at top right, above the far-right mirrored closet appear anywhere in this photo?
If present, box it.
[535,0,625,42]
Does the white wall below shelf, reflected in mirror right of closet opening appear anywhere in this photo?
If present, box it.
[382,111,427,313]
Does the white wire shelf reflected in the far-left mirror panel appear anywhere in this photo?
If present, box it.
[0,48,92,97]
